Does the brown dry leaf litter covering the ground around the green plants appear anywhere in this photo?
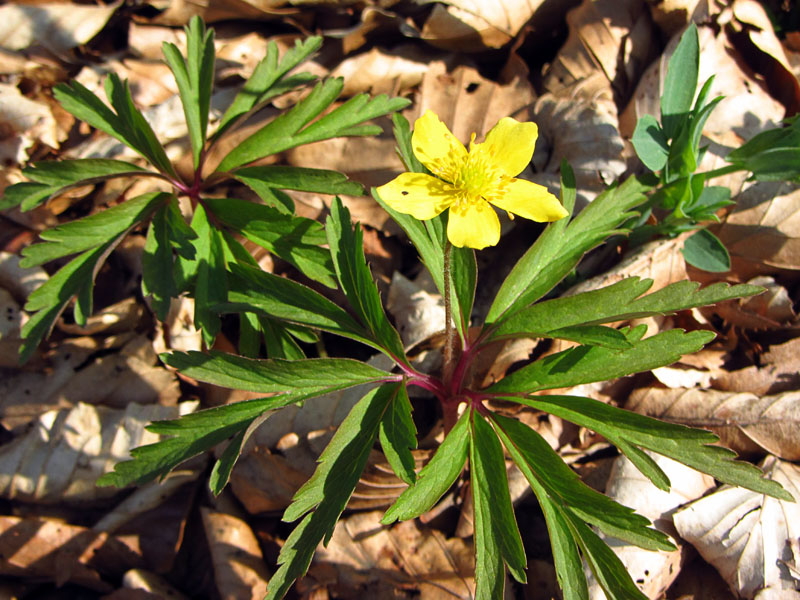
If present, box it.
[0,0,800,598]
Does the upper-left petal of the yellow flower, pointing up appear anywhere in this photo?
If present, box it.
[411,110,468,182]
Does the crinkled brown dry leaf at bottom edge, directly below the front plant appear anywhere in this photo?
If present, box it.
[310,511,475,600]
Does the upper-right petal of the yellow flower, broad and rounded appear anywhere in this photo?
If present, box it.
[473,117,539,177]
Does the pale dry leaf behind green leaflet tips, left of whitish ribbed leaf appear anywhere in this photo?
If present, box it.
[584,452,714,600]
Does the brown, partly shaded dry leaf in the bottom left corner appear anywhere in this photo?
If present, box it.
[0,516,144,593]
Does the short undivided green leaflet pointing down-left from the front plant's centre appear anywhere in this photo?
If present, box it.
[381,411,470,525]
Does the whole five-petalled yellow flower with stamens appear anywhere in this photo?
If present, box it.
[378,110,567,250]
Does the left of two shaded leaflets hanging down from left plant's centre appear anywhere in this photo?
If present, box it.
[142,204,178,321]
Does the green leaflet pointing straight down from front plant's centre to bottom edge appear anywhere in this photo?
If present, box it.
[470,411,527,598]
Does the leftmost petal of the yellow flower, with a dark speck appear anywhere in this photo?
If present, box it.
[377,173,455,220]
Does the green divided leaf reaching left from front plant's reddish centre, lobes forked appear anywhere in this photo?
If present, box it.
[98,352,391,493]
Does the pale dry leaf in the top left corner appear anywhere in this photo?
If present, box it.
[0,2,121,54]
